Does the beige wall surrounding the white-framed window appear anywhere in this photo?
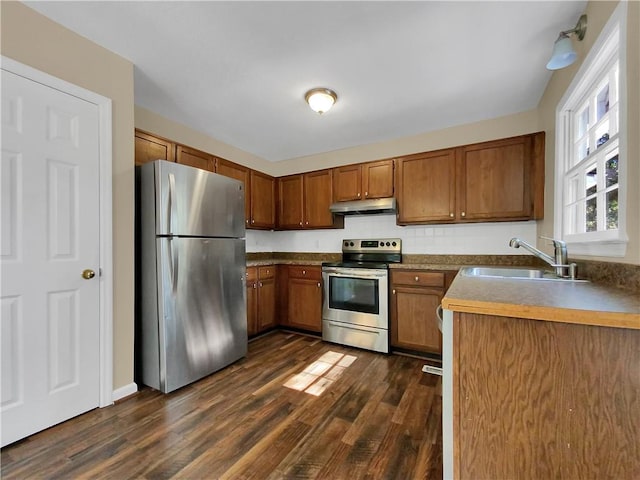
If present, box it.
[538,1,640,265]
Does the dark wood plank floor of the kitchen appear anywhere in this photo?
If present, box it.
[1,332,442,480]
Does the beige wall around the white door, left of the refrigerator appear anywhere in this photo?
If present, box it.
[0,1,134,389]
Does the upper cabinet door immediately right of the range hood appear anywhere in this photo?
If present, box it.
[396,149,456,225]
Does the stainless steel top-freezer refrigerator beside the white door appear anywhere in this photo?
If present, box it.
[136,160,247,393]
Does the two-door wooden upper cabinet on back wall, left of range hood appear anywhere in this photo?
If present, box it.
[278,170,344,230]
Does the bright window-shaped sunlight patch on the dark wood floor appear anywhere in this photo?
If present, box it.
[283,351,358,397]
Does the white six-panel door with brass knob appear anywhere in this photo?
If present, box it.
[0,70,100,446]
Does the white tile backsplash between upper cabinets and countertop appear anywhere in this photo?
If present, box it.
[247,214,537,255]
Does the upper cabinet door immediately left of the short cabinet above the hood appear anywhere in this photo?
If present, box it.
[304,170,333,228]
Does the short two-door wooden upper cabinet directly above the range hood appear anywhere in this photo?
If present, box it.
[333,160,393,202]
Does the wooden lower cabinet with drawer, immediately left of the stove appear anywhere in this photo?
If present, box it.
[286,265,322,333]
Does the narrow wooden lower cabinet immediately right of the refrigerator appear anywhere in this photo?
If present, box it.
[247,265,276,336]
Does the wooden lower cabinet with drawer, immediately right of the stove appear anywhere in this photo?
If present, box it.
[390,270,455,354]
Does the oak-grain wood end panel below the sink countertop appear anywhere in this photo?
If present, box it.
[453,312,640,479]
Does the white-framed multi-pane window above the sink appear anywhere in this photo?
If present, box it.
[555,2,627,256]
